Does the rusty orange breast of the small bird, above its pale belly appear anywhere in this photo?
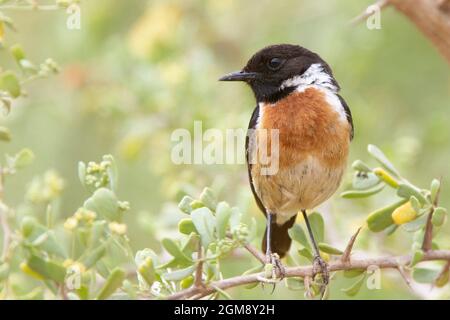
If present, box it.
[258,88,351,168]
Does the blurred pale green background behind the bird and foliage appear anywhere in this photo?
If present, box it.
[0,0,450,299]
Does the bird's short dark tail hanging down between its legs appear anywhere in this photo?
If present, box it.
[262,216,297,258]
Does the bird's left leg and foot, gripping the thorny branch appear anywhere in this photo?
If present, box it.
[259,213,285,289]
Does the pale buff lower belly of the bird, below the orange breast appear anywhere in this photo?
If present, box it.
[252,156,346,224]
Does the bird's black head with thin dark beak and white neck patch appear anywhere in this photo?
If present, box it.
[219,44,339,103]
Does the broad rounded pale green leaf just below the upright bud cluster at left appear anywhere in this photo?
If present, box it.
[84,188,122,221]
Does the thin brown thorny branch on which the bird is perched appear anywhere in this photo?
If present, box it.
[167,250,450,300]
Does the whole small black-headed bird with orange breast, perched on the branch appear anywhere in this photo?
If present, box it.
[219,44,353,285]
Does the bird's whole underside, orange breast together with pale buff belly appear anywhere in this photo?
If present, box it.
[249,88,351,224]
